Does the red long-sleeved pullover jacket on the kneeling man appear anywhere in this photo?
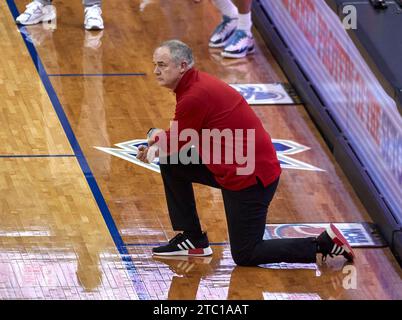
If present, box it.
[156,68,281,191]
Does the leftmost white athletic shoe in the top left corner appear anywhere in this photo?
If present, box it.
[16,1,56,25]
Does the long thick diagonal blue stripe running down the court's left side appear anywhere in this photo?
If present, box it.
[7,0,150,300]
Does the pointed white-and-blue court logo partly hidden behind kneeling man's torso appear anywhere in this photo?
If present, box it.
[95,139,325,173]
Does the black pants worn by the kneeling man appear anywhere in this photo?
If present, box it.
[160,164,317,266]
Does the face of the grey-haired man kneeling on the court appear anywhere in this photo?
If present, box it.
[153,47,185,90]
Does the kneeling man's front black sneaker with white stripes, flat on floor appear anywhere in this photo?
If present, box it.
[152,233,212,257]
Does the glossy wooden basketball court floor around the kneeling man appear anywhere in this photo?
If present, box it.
[0,0,402,300]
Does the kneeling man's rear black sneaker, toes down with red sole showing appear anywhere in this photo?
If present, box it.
[317,223,355,262]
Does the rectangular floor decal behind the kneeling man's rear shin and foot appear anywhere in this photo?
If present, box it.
[264,222,386,247]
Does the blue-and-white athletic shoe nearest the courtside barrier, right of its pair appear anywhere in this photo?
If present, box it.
[221,29,254,58]
